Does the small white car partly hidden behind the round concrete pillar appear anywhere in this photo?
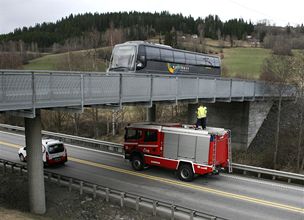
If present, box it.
[18,139,68,165]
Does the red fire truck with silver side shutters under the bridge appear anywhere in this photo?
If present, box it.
[124,123,231,181]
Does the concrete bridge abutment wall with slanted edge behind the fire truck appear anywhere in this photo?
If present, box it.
[188,101,273,149]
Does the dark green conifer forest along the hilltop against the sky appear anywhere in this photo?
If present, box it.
[0,11,254,48]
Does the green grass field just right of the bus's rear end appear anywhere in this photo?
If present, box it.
[222,47,271,79]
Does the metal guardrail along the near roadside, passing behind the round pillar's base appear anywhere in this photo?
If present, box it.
[0,159,225,220]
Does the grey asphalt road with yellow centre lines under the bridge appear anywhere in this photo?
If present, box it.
[0,131,304,220]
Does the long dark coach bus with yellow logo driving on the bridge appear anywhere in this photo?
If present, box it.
[108,41,221,76]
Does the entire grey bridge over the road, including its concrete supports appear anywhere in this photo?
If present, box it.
[0,70,296,213]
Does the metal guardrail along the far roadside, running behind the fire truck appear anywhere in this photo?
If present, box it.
[0,124,304,185]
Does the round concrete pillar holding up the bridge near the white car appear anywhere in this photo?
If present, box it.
[24,111,46,214]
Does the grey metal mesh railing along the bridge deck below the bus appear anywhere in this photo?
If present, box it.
[0,70,296,115]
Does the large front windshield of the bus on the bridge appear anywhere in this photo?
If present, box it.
[109,45,136,71]
